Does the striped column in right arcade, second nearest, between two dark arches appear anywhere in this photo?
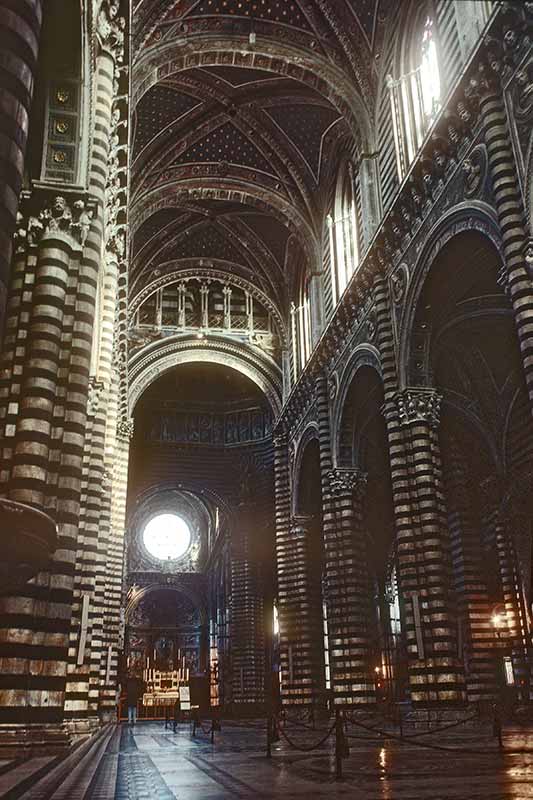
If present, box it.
[324,469,376,705]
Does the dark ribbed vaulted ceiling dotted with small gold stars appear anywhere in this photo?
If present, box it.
[130,0,385,320]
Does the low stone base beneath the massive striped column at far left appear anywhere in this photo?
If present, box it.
[0,723,72,759]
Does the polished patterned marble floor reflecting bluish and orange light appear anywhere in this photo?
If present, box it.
[0,721,533,800]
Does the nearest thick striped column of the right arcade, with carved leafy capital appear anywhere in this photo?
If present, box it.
[395,388,464,704]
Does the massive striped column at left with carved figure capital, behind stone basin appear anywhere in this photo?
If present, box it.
[0,195,88,746]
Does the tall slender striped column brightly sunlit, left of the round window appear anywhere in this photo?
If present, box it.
[65,31,121,728]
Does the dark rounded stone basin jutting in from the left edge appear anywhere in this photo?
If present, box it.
[0,498,57,594]
